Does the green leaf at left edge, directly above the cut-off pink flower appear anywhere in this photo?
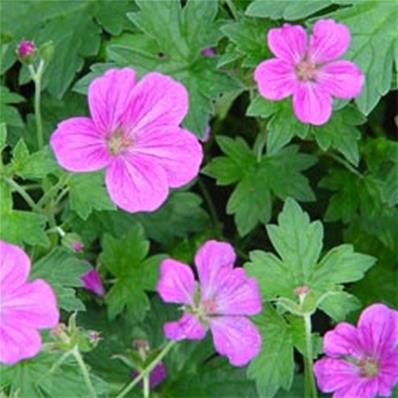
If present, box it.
[0,181,49,247]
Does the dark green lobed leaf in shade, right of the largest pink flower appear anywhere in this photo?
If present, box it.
[202,137,315,236]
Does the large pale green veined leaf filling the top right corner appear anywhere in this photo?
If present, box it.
[328,0,398,115]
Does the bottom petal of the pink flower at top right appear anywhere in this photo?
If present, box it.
[293,82,332,126]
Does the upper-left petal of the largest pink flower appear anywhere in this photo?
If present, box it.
[88,68,136,134]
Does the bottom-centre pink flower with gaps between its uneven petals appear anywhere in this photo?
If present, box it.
[157,240,261,366]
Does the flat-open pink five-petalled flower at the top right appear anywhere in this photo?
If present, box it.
[254,19,364,125]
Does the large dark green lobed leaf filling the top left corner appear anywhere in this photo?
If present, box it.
[1,0,132,98]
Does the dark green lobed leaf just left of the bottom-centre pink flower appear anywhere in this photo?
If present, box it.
[100,224,164,320]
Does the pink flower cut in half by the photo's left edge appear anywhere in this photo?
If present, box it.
[0,241,59,365]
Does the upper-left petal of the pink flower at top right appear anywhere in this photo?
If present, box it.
[268,24,307,64]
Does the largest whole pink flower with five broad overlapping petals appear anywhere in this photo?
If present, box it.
[51,68,203,212]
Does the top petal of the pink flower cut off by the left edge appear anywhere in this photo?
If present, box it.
[0,240,30,290]
